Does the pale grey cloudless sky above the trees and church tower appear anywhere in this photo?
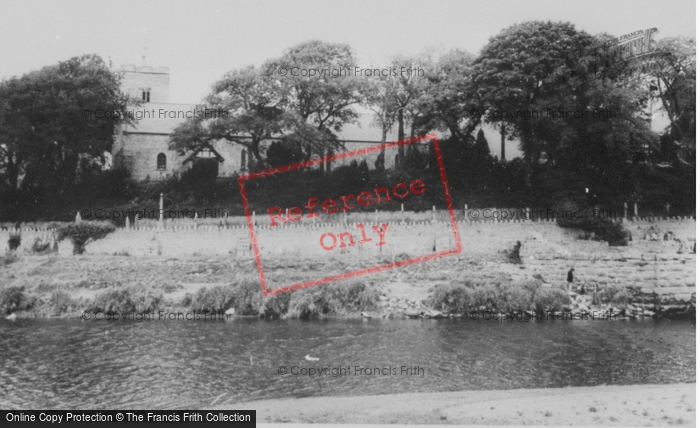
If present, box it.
[0,0,696,158]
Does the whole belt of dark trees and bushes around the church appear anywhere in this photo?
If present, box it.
[0,30,696,221]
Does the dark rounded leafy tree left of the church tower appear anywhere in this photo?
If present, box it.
[0,55,133,195]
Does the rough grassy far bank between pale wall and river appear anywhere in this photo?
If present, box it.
[0,254,695,320]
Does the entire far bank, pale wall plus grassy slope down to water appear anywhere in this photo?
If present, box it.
[0,220,695,318]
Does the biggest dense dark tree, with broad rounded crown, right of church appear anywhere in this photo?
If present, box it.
[473,21,654,203]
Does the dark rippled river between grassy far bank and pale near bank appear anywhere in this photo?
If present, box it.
[0,317,696,409]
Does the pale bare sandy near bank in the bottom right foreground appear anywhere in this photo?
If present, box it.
[219,383,696,426]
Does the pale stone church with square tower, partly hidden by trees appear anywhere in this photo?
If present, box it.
[111,65,398,181]
